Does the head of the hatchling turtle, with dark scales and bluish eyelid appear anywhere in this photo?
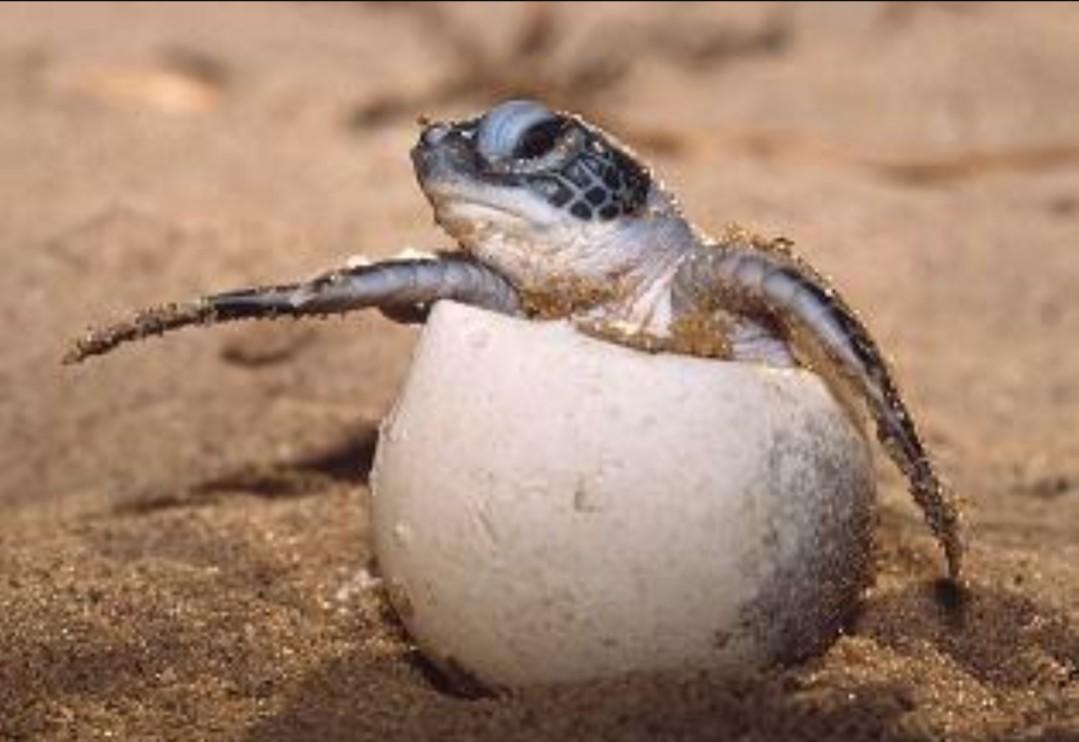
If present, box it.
[412,100,680,289]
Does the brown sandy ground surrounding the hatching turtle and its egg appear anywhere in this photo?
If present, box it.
[0,3,1079,740]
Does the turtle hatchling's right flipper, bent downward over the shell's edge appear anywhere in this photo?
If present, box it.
[672,235,962,579]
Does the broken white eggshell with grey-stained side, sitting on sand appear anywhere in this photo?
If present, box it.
[372,302,874,687]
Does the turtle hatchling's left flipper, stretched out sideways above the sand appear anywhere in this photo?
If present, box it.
[64,257,520,363]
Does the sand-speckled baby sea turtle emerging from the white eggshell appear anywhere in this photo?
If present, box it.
[65,100,962,579]
